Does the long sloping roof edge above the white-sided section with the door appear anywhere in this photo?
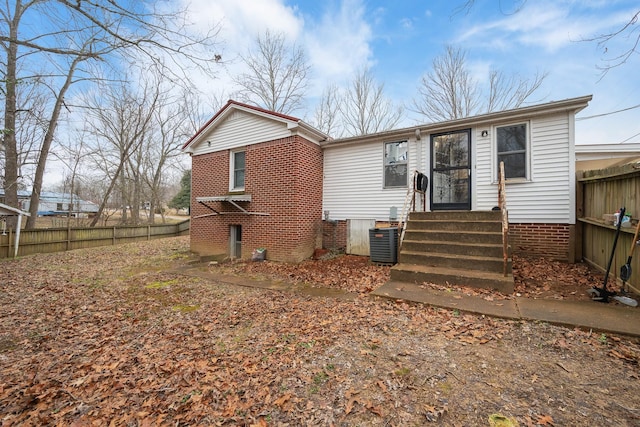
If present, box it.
[321,95,593,148]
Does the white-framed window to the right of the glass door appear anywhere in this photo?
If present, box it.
[496,123,528,179]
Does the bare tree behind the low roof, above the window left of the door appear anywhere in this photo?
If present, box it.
[340,68,404,136]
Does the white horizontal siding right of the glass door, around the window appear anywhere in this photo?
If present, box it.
[474,114,575,224]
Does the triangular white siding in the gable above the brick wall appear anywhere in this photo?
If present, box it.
[193,111,291,156]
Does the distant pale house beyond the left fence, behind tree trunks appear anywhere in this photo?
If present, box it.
[0,190,98,217]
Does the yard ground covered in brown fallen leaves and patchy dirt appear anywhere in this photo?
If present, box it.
[0,237,640,427]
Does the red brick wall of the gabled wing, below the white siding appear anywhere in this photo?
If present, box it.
[191,136,322,262]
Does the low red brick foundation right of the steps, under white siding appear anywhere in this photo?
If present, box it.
[509,224,573,261]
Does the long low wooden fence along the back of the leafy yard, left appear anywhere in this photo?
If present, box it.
[0,220,190,258]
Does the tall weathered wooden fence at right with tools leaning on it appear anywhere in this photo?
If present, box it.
[576,162,640,289]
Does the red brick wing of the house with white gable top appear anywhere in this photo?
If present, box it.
[183,101,328,262]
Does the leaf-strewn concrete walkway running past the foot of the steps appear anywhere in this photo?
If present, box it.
[174,265,640,337]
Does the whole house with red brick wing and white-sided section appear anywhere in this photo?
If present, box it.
[183,96,591,261]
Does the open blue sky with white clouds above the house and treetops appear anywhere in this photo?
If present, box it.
[179,0,640,144]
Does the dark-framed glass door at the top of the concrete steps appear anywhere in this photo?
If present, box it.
[431,129,471,211]
